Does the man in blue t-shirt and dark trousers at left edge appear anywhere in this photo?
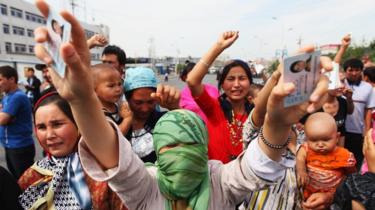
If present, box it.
[0,66,35,179]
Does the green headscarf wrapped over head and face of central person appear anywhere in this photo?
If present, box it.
[153,110,210,210]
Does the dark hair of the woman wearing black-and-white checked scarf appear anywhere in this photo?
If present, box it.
[34,92,77,125]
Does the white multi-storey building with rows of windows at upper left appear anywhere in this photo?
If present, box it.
[0,0,109,80]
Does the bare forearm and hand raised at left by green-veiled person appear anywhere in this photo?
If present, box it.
[35,0,119,169]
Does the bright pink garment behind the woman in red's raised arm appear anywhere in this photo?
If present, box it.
[180,84,219,124]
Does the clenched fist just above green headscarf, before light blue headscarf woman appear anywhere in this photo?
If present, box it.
[151,84,180,110]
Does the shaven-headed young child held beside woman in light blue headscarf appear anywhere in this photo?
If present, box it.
[92,64,133,135]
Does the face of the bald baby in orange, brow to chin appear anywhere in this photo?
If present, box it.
[307,132,337,154]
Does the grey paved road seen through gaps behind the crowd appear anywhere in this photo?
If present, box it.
[0,74,217,170]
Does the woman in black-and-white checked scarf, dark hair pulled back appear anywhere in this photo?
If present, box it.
[18,92,126,210]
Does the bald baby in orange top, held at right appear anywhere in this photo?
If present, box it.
[296,112,356,200]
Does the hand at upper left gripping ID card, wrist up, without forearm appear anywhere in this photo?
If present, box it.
[34,0,95,102]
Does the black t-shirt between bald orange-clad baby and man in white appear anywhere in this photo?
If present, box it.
[300,96,348,136]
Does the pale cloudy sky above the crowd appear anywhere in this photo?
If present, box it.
[29,0,375,60]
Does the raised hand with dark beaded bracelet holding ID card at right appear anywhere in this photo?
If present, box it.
[259,47,332,161]
